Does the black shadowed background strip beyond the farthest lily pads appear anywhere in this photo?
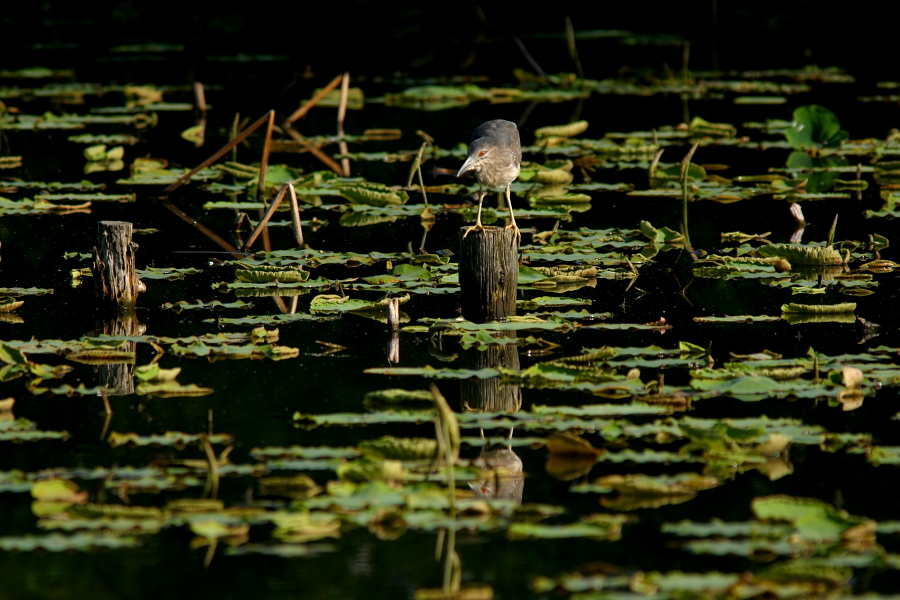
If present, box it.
[0,0,896,79]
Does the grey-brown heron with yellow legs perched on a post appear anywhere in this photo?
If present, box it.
[456,119,522,239]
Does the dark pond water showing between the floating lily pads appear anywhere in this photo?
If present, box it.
[0,9,900,599]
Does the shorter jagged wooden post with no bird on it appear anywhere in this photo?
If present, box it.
[91,221,146,309]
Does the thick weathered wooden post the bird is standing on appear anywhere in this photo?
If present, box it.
[459,227,519,323]
